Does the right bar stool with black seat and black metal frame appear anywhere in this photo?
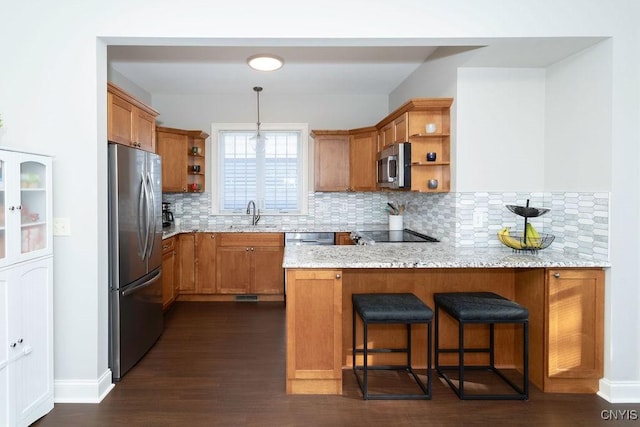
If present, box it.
[433,292,529,400]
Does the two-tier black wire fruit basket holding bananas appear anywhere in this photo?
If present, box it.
[498,199,555,252]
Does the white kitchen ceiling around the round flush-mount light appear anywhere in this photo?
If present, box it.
[107,37,603,95]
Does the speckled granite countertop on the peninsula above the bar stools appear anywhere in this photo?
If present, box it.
[283,243,610,268]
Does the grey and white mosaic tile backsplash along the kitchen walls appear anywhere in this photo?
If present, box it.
[163,192,609,261]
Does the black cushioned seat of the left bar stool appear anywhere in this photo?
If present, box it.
[353,294,433,323]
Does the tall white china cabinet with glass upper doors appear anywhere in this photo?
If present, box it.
[0,149,53,426]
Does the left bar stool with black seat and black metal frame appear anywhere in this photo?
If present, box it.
[352,293,433,400]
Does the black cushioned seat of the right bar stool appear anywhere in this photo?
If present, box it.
[433,292,529,323]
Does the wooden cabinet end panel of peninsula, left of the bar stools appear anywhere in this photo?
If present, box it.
[286,270,342,394]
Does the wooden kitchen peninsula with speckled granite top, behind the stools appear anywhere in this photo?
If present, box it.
[283,243,609,394]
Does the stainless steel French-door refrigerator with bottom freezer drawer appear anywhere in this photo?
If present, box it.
[109,143,163,381]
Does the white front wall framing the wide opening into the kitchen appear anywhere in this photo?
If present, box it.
[0,0,640,402]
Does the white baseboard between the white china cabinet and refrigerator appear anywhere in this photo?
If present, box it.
[53,369,115,403]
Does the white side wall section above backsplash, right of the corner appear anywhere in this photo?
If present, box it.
[543,41,613,192]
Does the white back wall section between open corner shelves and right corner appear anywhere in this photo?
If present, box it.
[455,68,545,192]
